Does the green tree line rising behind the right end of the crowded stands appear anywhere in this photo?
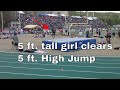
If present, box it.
[69,11,120,26]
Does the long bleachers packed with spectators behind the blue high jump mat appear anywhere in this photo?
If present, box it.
[16,13,109,29]
